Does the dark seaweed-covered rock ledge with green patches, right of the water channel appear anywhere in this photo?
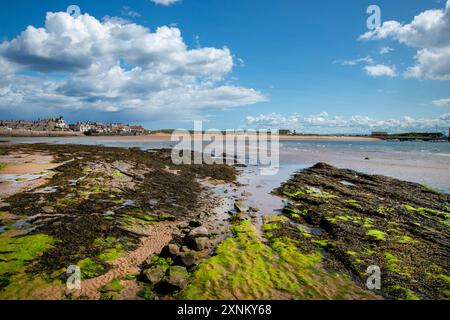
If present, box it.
[274,163,450,299]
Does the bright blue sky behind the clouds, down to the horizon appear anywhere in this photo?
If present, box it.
[0,0,450,132]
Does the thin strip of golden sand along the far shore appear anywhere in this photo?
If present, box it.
[0,132,380,141]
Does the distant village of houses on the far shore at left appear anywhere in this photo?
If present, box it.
[0,117,145,135]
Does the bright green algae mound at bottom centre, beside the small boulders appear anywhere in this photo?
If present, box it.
[178,221,374,300]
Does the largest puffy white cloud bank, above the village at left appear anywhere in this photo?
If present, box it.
[0,12,266,120]
